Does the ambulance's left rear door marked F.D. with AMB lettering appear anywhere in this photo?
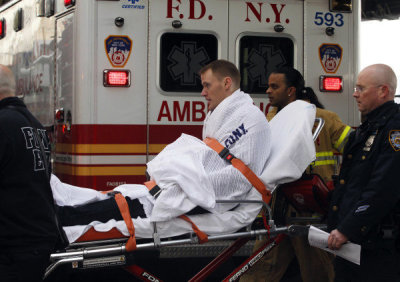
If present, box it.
[148,0,230,155]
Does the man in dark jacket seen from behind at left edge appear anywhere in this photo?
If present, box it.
[0,65,58,282]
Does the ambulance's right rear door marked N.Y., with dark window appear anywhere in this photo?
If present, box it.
[229,0,304,113]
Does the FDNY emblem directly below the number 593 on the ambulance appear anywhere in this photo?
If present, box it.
[319,43,343,73]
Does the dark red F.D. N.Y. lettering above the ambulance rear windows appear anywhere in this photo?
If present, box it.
[166,0,290,24]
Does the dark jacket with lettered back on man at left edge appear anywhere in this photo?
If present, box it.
[0,97,58,251]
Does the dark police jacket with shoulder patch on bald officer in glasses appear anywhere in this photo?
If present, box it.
[328,102,400,247]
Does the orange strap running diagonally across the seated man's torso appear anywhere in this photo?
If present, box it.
[203,137,271,204]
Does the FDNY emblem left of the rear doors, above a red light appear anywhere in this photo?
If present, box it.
[104,35,132,68]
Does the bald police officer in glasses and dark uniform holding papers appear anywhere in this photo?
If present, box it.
[328,64,400,281]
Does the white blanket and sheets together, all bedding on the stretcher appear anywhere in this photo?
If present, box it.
[51,98,315,242]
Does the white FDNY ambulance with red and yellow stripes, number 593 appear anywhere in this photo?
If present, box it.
[0,0,361,190]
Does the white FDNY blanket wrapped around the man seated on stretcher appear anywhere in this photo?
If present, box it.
[147,90,271,221]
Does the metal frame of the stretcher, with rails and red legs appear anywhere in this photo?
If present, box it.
[44,118,325,281]
